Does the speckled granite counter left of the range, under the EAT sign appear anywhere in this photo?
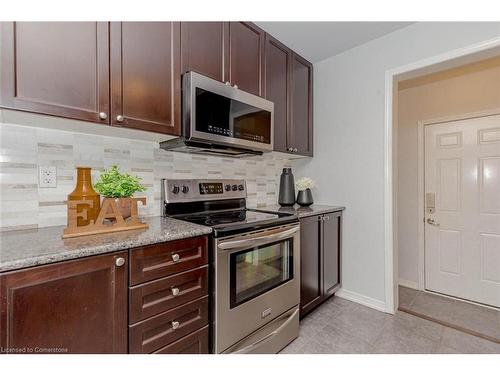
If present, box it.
[0,216,212,272]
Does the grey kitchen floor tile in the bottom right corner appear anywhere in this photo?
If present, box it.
[441,327,500,354]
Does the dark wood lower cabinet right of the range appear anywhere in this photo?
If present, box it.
[300,211,342,318]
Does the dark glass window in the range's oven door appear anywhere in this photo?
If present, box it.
[229,239,293,308]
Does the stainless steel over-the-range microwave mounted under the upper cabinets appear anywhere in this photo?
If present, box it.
[160,72,274,157]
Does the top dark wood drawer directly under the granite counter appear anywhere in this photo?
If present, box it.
[130,236,208,285]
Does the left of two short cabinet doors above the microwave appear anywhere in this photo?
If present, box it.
[181,22,229,81]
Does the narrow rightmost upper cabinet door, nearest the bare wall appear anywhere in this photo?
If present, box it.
[288,54,313,156]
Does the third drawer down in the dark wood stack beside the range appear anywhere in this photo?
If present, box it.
[129,296,208,353]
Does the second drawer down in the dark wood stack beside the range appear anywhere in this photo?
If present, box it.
[129,265,208,324]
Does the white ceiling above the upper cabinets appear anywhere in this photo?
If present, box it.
[256,22,413,63]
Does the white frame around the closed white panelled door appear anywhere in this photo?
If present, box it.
[417,108,500,292]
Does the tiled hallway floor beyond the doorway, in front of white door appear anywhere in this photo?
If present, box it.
[399,286,500,340]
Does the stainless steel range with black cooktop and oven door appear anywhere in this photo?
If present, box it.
[162,179,300,353]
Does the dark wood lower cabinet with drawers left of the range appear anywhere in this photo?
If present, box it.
[0,236,209,354]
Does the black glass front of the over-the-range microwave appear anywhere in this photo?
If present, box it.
[195,87,271,144]
